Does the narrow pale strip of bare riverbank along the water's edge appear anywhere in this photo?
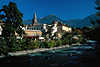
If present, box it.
[0,44,81,58]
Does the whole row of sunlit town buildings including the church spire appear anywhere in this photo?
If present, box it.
[0,13,72,39]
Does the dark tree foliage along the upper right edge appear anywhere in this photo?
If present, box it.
[89,0,100,41]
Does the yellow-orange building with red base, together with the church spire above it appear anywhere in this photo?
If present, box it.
[24,13,43,39]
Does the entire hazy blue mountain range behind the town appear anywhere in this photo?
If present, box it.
[24,14,97,28]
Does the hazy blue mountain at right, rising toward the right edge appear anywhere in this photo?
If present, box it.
[65,14,97,28]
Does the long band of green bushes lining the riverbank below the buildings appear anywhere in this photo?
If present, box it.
[0,36,85,56]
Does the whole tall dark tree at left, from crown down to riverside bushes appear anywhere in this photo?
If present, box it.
[0,2,24,53]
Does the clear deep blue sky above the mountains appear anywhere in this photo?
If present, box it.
[0,0,95,20]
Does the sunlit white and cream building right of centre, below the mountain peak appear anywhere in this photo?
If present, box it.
[49,21,72,39]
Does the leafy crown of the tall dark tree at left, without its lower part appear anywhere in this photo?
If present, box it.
[2,2,23,38]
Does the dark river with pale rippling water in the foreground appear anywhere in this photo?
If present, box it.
[0,41,96,67]
